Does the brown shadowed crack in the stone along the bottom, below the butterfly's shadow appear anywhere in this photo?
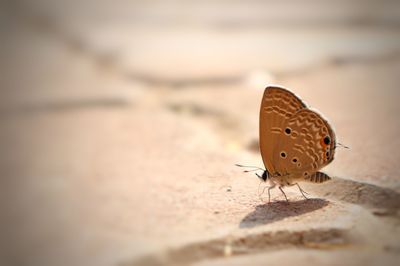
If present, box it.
[121,228,350,266]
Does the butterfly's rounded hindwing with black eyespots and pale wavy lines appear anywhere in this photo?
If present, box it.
[273,109,336,178]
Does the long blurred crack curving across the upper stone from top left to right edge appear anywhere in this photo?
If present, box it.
[19,13,400,89]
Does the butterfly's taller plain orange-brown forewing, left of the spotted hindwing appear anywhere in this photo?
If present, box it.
[259,86,306,174]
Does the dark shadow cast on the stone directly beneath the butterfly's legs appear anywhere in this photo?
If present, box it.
[239,199,329,228]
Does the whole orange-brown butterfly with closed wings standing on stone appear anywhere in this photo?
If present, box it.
[238,86,336,201]
